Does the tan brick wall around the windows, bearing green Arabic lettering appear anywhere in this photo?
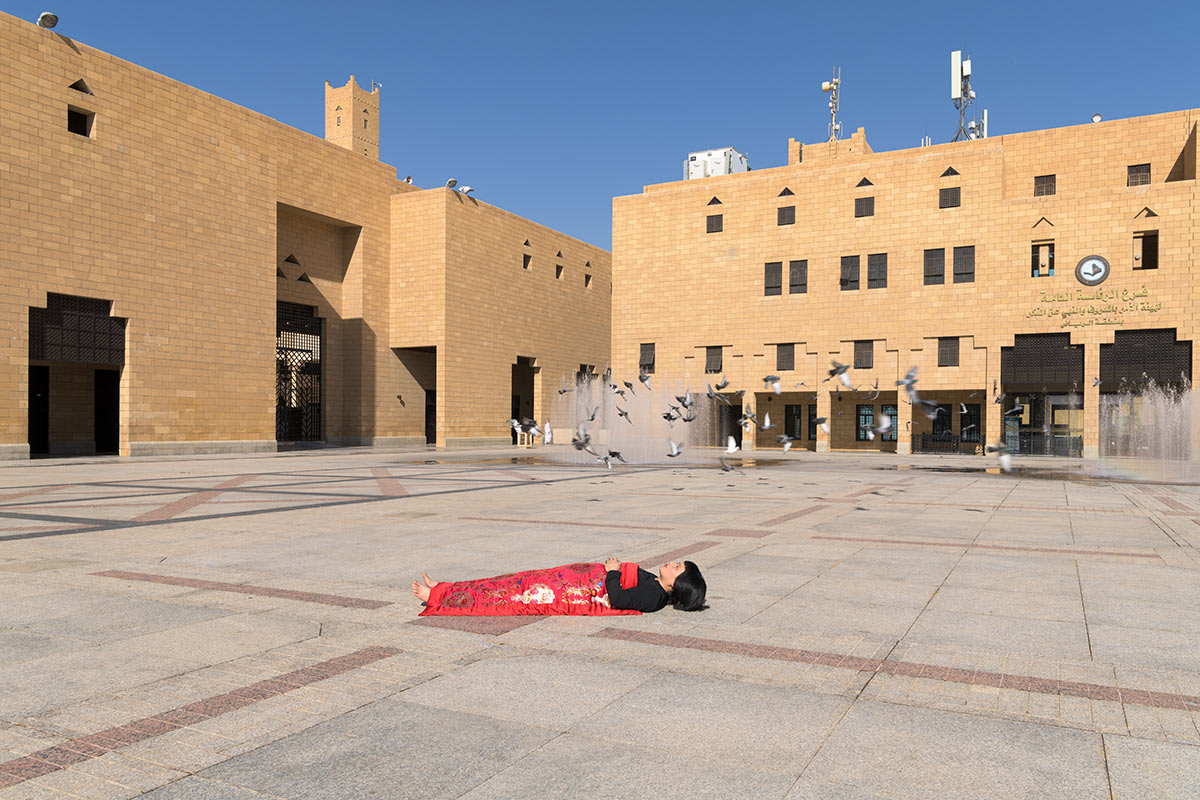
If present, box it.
[613,110,1200,450]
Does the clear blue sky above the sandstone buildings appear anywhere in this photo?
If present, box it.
[11,0,1200,247]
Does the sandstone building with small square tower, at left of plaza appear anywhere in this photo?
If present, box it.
[0,14,612,458]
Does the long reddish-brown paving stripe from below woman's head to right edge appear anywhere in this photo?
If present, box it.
[592,627,1200,711]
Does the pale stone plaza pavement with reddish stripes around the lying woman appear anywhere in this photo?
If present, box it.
[0,446,1200,800]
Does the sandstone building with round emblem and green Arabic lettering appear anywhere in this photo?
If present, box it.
[612,110,1200,457]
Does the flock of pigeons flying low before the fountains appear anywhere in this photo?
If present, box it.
[508,361,1118,473]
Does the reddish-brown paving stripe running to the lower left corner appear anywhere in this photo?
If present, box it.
[0,648,400,789]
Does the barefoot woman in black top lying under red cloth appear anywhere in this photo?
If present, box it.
[413,559,708,616]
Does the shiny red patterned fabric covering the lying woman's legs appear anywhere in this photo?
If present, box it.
[421,564,641,616]
